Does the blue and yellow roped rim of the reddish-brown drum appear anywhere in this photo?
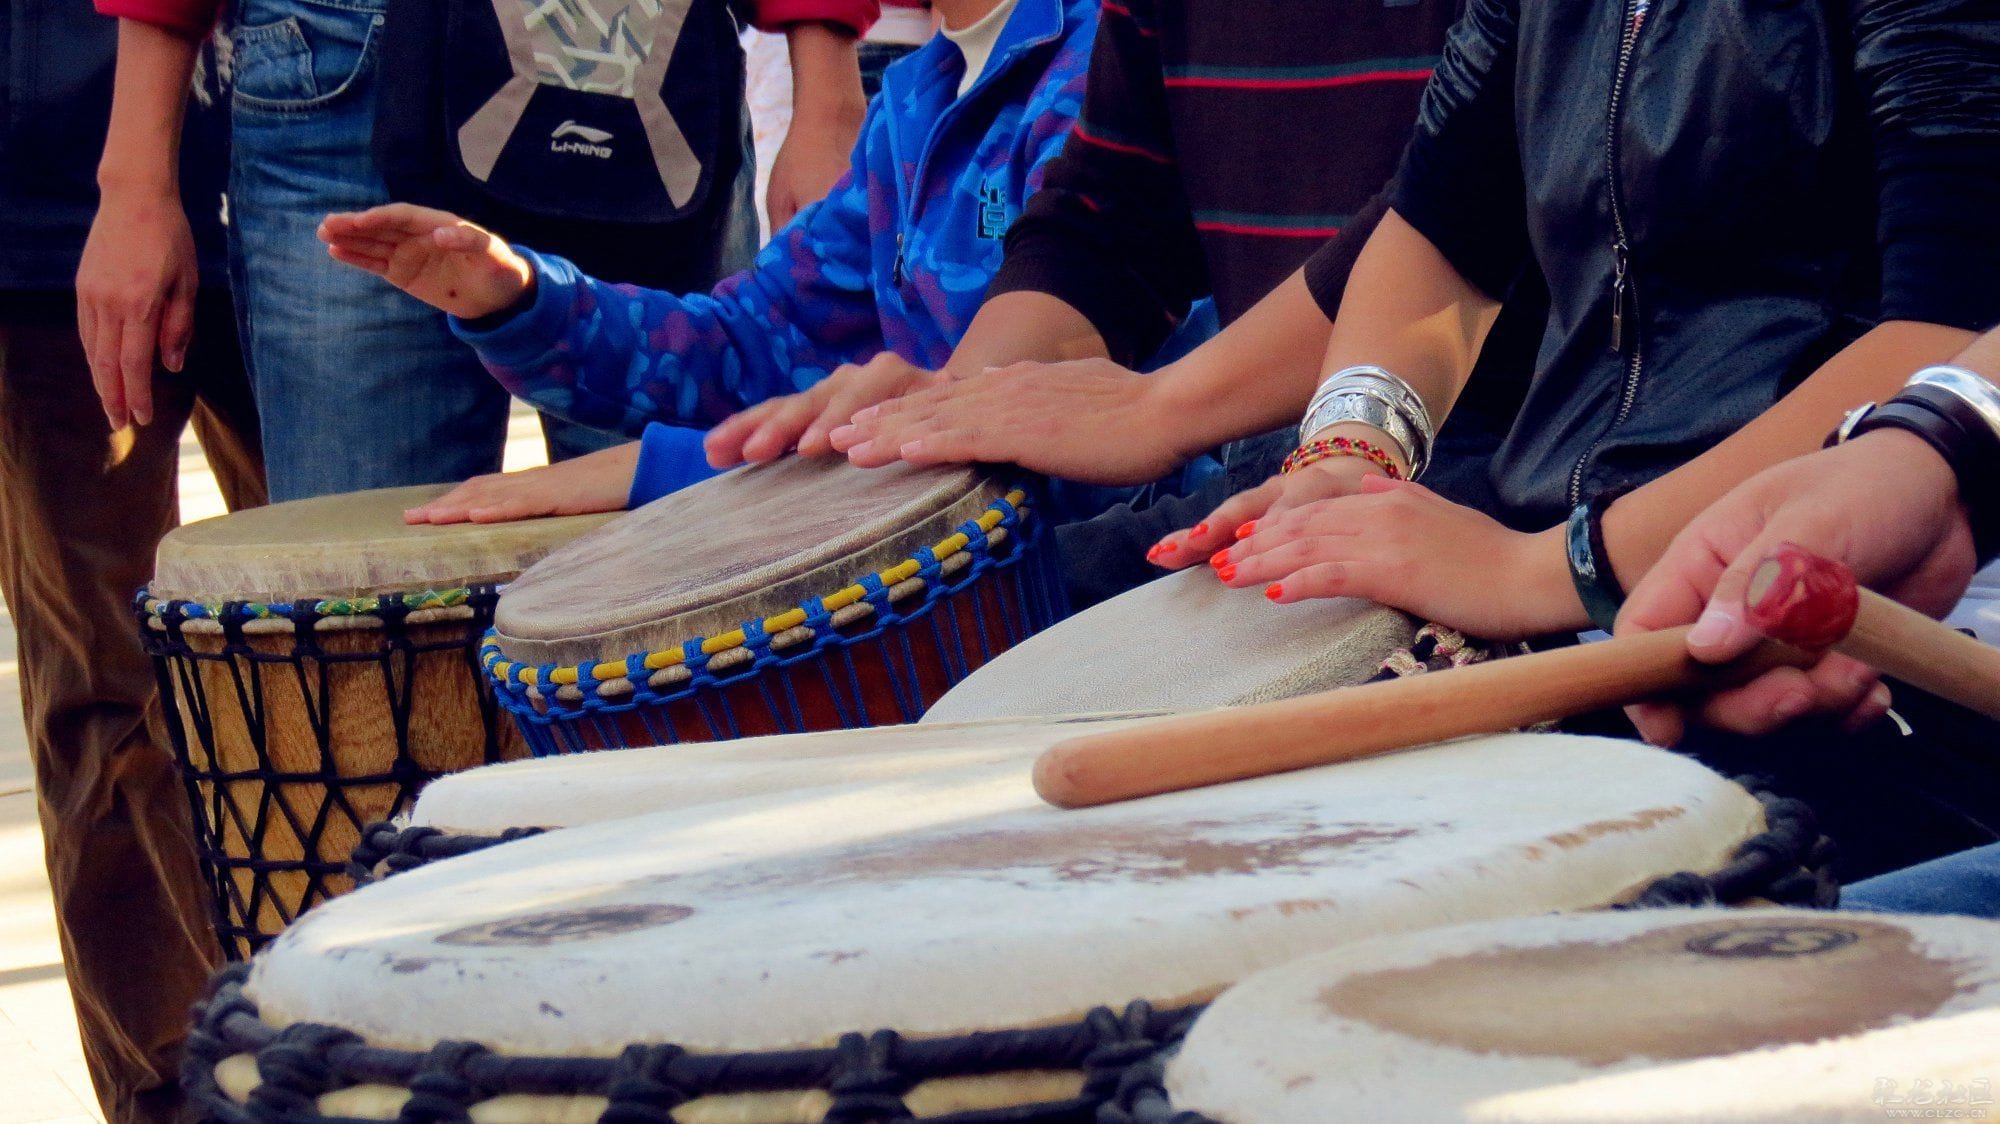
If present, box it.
[480,484,1034,700]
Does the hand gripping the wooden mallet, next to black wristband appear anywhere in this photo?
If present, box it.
[1618,438,1972,746]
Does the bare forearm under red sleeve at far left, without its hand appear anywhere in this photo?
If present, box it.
[98,20,198,206]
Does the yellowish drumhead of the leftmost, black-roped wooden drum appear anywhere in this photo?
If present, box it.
[148,484,612,602]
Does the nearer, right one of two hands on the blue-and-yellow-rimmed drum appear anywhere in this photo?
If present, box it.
[834,358,1192,484]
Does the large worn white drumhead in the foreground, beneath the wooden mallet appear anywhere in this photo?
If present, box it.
[246,726,1764,1056]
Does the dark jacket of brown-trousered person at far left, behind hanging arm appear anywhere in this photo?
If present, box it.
[0,0,228,290]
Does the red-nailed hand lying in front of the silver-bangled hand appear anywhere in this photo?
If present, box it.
[1210,472,1578,640]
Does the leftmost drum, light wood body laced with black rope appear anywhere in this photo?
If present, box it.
[138,486,606,956]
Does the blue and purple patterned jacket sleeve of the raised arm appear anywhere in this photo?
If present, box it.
[452,100,900,436]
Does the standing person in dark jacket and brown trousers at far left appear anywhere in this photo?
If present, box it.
[0,10,264,1122]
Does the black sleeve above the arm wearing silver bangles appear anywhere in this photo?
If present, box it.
[1384,0,1528,300]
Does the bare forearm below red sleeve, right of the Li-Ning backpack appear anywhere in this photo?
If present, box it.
[764,16,872,230]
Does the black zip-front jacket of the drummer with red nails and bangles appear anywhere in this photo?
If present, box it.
[1390,0,2000,528]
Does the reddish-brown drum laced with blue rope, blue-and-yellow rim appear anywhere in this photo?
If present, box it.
[484,456,1062,754]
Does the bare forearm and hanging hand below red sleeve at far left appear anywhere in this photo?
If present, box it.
[76,20,198,428]
